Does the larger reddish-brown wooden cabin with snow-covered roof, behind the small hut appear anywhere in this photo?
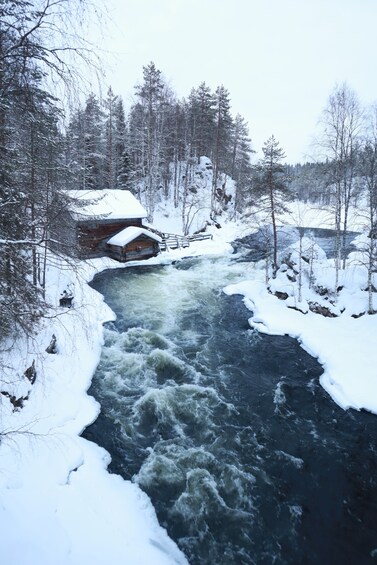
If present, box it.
[60,190,147,258]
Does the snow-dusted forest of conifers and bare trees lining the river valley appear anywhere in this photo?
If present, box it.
[0,0,377,344]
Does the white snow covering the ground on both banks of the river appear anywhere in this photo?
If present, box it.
[0,200,377,565]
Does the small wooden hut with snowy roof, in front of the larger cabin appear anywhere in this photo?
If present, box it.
[107,226,162,263]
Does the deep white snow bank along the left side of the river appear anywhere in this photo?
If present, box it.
[0,254,187,565]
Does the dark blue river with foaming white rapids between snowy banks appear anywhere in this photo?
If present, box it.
[85,229,377,565]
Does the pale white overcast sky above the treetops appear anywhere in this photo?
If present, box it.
[93,0,377,163]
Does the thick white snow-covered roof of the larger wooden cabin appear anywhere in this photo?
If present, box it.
[66,190,148,220]
